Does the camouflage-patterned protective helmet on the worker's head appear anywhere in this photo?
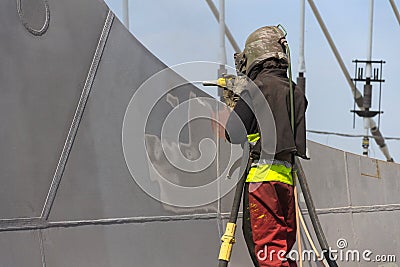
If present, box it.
[243,26,288,74]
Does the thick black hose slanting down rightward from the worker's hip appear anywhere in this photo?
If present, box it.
[295,158,338,267]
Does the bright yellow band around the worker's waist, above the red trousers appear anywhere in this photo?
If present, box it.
[246,164,293,185]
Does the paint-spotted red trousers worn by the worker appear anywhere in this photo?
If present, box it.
[243,182,297,267]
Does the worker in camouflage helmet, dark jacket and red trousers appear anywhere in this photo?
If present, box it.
[225,26,307,267]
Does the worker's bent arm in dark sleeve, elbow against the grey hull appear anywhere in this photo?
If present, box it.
[225,93,257,144]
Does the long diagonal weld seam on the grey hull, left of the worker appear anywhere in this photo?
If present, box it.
[40,10,114,220]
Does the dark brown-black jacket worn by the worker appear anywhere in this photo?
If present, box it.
[225,68,307,160]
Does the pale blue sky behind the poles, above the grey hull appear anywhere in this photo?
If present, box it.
[106,0,400,162]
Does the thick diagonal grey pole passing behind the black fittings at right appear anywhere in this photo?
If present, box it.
[308,0,393,162]
